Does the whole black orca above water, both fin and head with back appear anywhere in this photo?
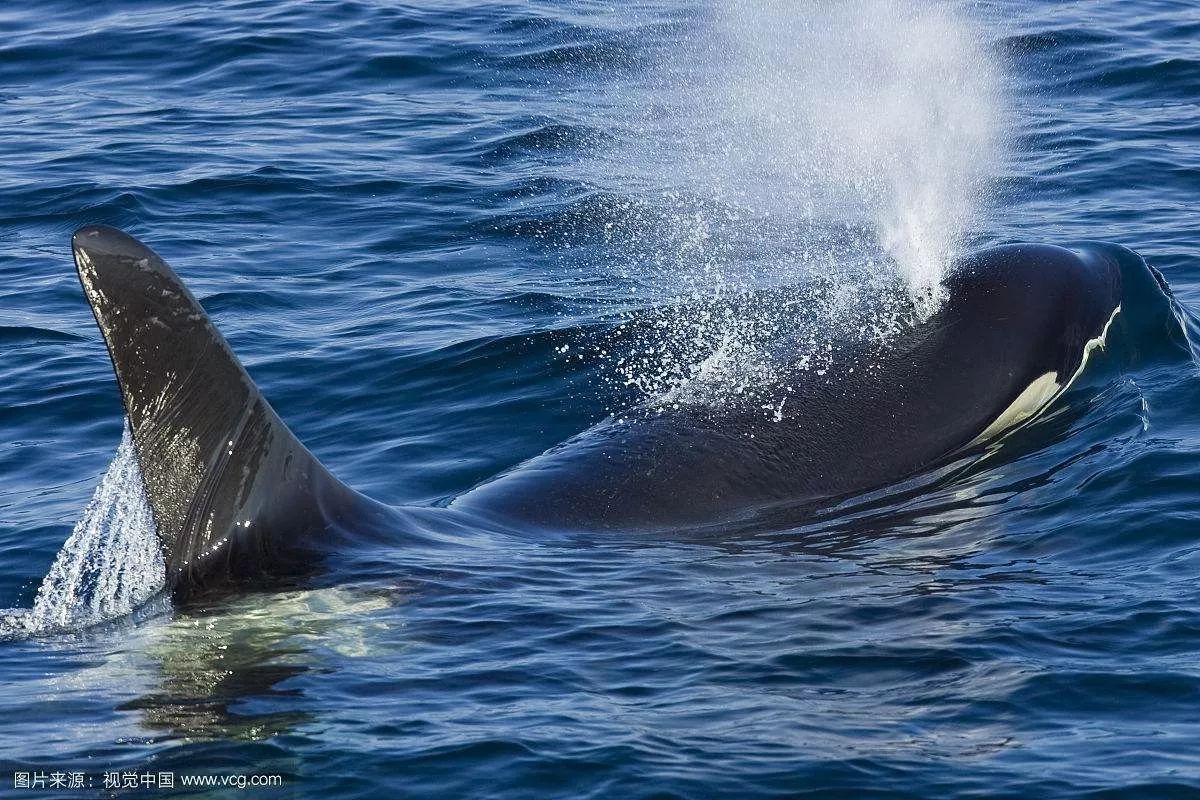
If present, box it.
[72,225,1165,599]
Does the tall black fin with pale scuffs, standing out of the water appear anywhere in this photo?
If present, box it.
[72,225,377,597]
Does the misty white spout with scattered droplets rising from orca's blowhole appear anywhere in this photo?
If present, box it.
[582,0,1004,416]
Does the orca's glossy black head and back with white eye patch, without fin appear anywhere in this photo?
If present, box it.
[455,245,1123,530]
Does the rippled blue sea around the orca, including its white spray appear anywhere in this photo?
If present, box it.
[0,0,1200,799]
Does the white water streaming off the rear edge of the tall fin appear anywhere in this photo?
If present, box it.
[0,425,166,636]
